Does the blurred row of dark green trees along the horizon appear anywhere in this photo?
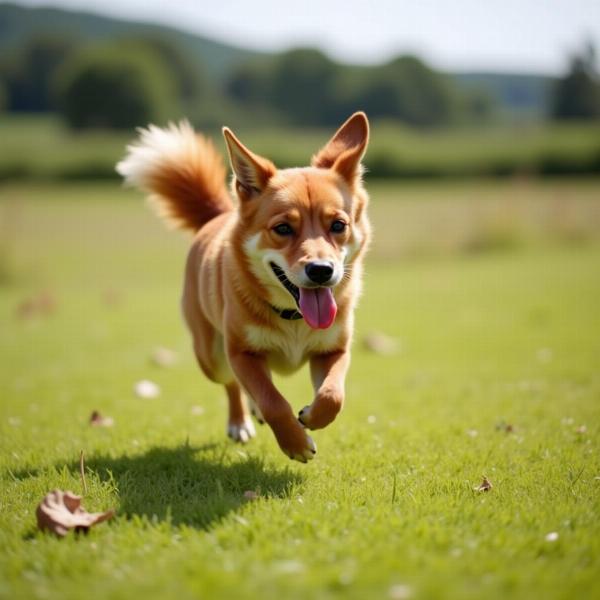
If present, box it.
[0,35,600,129]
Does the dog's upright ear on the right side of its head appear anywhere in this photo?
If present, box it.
[311,112,369,183]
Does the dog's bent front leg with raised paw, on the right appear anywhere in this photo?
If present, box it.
[298,350,350,429]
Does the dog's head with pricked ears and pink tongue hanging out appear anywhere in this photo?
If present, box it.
[223,112,369,329]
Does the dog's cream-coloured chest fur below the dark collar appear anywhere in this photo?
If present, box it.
[246,321,341,373]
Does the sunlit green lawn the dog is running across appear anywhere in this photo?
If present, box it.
[0,181,600,600]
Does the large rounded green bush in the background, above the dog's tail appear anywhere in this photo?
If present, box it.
[57,46,177,129]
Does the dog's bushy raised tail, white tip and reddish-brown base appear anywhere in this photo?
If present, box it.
[117,121,233,231]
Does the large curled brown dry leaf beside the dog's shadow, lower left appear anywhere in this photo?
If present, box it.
[36,490,115,537]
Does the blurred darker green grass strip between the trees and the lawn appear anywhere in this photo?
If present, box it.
[0,115,600,180]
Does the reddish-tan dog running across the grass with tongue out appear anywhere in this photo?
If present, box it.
[117,112,371,463]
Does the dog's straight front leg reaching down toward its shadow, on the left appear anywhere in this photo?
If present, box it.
[229,350,317,462]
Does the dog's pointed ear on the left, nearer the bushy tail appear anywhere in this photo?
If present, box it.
[223,127,277,200]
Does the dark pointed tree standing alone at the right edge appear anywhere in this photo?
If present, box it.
[552,43,600,120]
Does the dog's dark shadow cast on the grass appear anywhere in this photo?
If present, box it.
[13,444,302,529]
